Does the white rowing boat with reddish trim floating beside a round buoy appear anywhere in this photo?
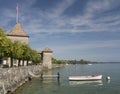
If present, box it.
[68,75,102,81]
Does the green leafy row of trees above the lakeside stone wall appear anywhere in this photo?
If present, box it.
[0,28,41,63]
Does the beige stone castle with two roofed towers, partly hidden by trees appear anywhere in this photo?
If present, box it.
[7,23,52,69]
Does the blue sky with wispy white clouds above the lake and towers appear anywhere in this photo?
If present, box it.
[0,0,120,61]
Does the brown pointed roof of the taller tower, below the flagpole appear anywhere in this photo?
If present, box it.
[8,23,28,37]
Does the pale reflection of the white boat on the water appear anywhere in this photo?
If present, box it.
[69,80,103,86]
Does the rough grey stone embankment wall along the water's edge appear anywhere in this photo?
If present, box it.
[0,65,42,94]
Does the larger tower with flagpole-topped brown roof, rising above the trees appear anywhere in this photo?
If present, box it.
[7,23,29,44]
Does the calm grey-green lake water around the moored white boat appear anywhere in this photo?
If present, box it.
[15,63,120,94]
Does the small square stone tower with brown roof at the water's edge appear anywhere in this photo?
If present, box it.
[42,47,53,69]
